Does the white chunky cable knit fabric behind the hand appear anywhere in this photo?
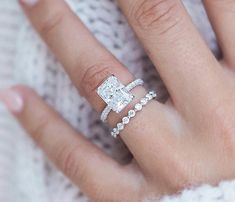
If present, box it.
[0,0,235,202]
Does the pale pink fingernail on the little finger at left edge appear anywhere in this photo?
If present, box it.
[0,89,23,113]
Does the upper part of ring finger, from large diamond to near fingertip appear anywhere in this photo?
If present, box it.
[20,0,138,111]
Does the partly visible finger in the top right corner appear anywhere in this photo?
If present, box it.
[204,0,235,68]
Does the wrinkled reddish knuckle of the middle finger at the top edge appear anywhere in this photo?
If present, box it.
[130,0,180,34]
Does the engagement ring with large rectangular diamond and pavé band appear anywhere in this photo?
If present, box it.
[97,76,144,122]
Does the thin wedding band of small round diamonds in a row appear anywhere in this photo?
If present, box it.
[111,91,157,138]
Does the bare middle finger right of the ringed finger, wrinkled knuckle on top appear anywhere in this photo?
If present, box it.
[119,0,224,118]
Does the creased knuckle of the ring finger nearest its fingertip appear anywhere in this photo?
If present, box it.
[39,10,66,37]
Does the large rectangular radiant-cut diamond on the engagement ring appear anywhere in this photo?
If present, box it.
[97,76,134,113]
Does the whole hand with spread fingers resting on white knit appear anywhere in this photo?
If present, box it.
[0,0,235,202]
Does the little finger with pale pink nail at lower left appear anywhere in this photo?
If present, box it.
[0,86,140,201]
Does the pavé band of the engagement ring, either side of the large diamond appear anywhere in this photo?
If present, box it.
[100,79,144,122]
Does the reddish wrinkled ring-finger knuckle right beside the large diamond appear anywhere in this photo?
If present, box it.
[79,63,112,98]
